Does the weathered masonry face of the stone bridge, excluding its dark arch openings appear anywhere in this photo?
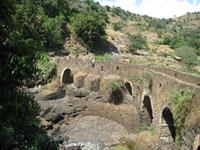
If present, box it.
[57,59,200,148]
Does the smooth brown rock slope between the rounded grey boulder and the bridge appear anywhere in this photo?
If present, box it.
[82,102,139,132]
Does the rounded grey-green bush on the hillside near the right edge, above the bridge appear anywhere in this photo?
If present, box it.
[175,47,198,68]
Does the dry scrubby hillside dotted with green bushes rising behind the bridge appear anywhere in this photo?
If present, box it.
[64,1,200,76]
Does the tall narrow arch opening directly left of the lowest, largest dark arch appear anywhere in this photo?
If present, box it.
[142,95,153,125]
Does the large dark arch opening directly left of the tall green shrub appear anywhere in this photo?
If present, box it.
[161,107,176,141]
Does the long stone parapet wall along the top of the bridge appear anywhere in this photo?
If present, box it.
[57,59,200,86]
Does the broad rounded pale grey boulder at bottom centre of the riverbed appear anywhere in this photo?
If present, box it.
[62,116,127,146]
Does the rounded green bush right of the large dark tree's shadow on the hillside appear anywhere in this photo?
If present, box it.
[128,34,148,52]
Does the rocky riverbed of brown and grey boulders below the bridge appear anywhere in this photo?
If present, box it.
[29,82,169,150]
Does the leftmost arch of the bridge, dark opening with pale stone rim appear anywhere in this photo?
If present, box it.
[61,68,74,84]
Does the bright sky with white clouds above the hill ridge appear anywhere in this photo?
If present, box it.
[94,0,200,18]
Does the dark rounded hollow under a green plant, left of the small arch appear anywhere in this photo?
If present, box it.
[109,88,124,105]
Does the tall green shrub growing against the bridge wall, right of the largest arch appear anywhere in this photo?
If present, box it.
[170,87,193,145]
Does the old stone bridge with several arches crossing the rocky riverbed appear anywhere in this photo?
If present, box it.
[57,59,200,149]
